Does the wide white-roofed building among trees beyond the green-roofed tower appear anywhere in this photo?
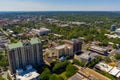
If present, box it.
[32,28,51,36]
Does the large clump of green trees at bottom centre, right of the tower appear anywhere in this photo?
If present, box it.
[40,61,78,80]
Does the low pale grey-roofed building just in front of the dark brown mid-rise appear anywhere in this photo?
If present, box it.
[75,52,98,62]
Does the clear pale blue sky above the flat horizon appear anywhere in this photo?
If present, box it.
[0,0,120,11]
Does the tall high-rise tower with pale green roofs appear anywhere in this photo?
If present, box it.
[7,38,44,74]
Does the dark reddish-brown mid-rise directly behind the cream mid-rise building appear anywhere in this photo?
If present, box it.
[63,38,82,53]
